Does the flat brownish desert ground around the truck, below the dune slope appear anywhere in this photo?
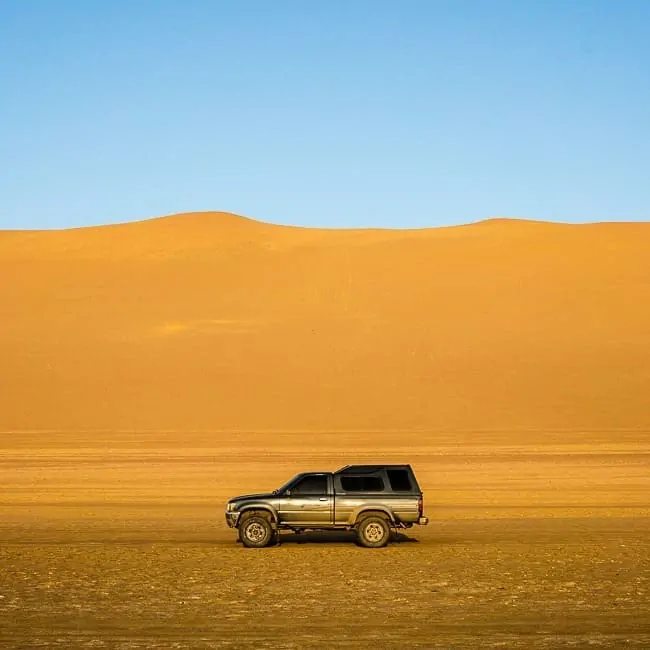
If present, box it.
[0,431,650,649]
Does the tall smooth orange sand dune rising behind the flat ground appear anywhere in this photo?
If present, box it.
[0,213,650,432]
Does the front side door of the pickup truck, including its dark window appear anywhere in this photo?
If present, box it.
[279,474,334,526]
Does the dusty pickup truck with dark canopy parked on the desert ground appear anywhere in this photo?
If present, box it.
[226,465,429,548]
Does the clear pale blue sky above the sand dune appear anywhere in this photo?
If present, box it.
[0,0,650,228]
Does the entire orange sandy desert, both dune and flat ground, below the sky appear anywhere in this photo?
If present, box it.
[0,213,650,650]
